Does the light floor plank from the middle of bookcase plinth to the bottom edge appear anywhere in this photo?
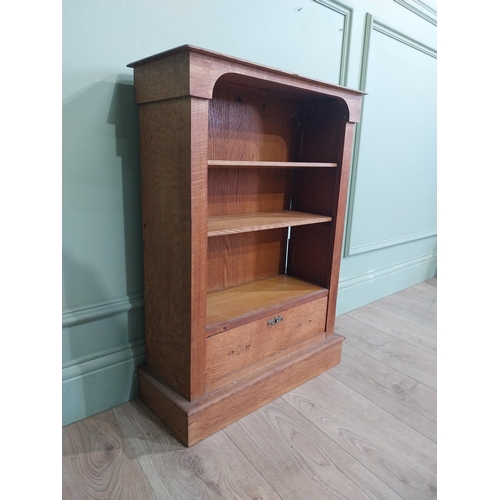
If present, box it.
[225,399,401,500]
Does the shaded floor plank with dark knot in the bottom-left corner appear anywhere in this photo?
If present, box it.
[62,410,156,500]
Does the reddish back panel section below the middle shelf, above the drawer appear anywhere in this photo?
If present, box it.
[207,228,288,292]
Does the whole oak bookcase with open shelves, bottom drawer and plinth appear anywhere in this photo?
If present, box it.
[129,45,363,446]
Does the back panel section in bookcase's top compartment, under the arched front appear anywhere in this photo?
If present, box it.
[208,86,298,161]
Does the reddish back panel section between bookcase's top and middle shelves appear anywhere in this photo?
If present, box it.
[208,168,292,217]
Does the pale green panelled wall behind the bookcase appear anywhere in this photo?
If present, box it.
[62,0,436,424]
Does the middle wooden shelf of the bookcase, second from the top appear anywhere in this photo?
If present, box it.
[208,210,332,238]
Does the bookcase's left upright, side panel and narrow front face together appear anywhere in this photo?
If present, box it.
[139,98,208,399]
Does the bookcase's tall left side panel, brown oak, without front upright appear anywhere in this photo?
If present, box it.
[139,98,192,399]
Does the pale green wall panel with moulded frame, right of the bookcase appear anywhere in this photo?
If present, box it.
[345,15,436,256]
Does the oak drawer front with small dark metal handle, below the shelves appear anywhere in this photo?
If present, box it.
[205,297,327,385]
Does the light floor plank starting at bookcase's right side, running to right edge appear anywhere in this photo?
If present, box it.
[335,314,436,390]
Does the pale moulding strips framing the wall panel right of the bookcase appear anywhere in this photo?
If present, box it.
[344,13,437,257]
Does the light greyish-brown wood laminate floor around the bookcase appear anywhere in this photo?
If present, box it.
[62,278,437,500]
